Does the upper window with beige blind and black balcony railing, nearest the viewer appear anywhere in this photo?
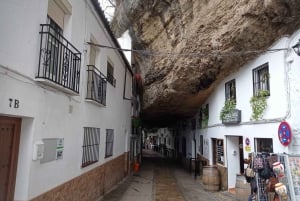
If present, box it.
[36,0,81,94]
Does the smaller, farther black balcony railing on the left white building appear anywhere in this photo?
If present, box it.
[86,65,107,105]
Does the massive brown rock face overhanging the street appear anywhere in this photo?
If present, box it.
[111,0,300,123]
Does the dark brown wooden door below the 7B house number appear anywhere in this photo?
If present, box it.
[0,116,21,201]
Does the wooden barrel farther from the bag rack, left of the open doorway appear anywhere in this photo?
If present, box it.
[202,166,220,191]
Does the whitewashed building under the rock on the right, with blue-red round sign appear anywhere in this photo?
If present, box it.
[178,31,300,190]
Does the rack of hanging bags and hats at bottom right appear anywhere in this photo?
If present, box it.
[246,152,300,201]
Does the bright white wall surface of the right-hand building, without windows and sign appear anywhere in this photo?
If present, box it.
[185,31,300,188]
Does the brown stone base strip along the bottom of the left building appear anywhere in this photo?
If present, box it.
[31,153,128,201]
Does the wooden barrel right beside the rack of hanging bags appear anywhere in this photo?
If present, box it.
[235,175,251,200]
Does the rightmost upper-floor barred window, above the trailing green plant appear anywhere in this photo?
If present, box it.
[253,63,270,96]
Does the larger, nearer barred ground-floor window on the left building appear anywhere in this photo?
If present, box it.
[81,127,100,167]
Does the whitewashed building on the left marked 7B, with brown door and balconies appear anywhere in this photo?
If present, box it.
[0,0,133,201]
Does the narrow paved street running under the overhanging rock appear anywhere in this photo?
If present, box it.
[97,150,241,201]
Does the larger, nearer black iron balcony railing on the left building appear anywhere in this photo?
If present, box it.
[36,24,81,94]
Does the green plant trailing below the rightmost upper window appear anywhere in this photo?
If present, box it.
[250,90,270,121]
